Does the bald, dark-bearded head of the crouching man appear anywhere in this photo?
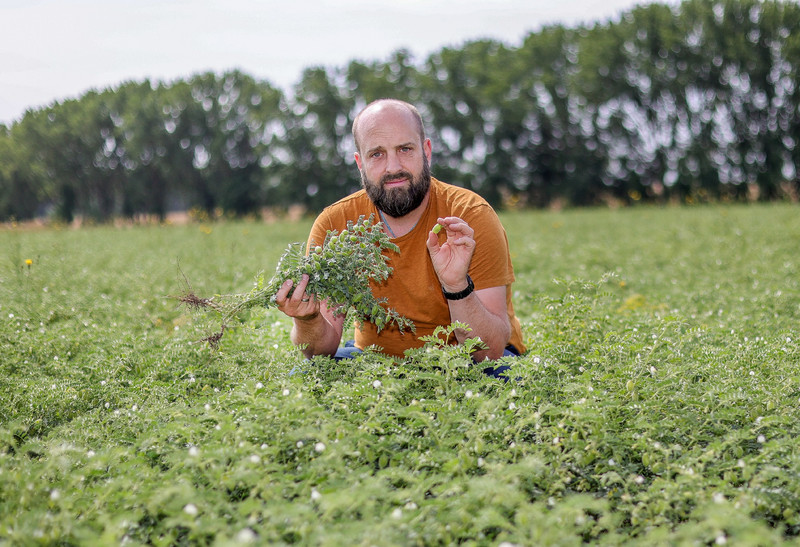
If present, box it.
[353,99,431,218]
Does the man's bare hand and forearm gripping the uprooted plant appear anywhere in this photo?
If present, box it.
[275,275,345,359]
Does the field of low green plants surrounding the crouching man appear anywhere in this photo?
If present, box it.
[0,205,800,545]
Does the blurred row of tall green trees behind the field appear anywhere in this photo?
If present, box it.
[0,0,800,224]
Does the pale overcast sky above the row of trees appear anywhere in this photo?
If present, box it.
[0,0,677,125]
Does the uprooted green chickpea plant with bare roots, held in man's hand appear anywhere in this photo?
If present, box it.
[178,216,414,348]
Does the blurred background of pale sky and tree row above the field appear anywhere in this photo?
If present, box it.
[0,0,800,223]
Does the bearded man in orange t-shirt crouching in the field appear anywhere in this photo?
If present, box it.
[276,99,525,361]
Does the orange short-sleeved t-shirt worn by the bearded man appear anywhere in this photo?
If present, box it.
[307,178,525,356]
